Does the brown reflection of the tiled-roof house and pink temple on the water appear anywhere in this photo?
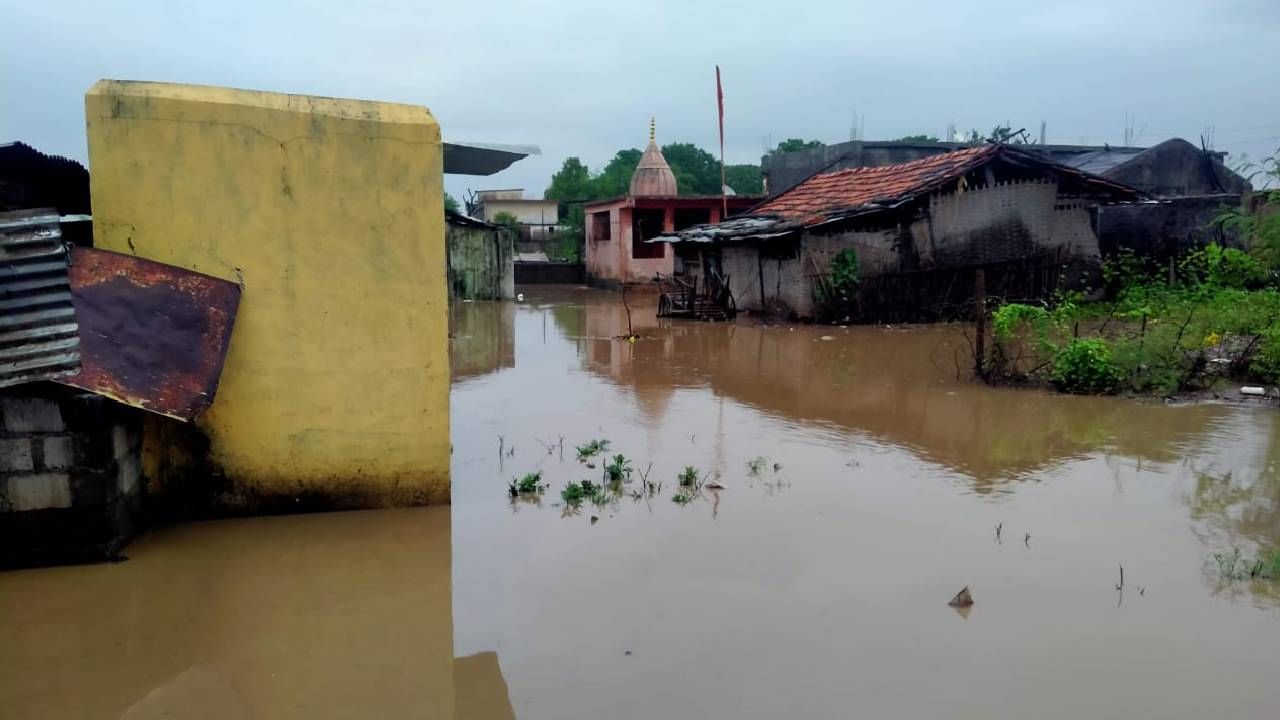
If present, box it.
[554,285,1230,493]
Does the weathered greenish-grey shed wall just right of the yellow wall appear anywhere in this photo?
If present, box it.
[445,224,516,300]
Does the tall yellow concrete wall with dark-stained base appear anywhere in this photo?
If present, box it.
[84,81,449,507]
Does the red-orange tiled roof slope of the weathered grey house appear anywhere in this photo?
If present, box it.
[751,145,1002,224]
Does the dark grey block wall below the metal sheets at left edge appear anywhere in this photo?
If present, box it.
[0,384,143,568]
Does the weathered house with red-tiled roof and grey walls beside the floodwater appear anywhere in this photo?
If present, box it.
[662,145,1139,320]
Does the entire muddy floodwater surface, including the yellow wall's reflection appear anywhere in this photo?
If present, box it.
[0,283,1280,720]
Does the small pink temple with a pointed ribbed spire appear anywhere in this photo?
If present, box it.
[582,119,760,286]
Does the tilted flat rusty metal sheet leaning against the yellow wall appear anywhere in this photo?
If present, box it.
[59,247,241,420]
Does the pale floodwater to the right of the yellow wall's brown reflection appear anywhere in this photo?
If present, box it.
[453,290,1280,719]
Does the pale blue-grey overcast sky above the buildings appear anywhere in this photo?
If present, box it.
[0,0,1280,197]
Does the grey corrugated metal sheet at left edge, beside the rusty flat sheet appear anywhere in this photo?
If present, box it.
[0,209,81,387]
